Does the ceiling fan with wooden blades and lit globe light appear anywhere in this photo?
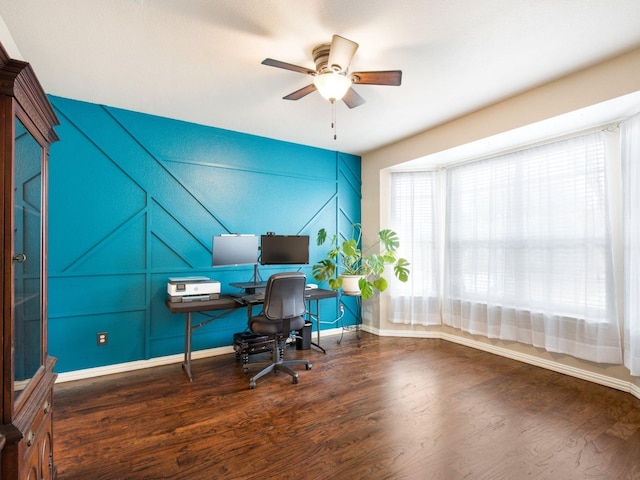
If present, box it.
[262,35,402,108]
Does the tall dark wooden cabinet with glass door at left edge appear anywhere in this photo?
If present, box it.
[0,45,58,480]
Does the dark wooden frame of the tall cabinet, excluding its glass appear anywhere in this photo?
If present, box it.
[0,41,59,480]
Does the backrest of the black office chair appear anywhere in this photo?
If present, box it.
[262,272,307,320]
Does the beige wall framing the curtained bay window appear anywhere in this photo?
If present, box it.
[362,48,640,394]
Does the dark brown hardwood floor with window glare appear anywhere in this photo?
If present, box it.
[54,334,640,480]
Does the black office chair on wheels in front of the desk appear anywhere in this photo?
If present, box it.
[247,272,311,388]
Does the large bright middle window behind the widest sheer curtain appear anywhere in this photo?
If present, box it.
[447,134,612,321]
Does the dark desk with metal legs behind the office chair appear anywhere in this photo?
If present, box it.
[164,288,338,382]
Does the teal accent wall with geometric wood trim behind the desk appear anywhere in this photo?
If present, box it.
[48,96,361,373]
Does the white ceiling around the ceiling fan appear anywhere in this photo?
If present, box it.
[0,0,640,154]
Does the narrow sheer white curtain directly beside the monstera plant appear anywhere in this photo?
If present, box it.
[388,172,441,325]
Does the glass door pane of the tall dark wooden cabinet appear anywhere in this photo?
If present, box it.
[13,118,43,400]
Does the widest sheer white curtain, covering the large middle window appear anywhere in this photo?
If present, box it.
[443,133,622,364]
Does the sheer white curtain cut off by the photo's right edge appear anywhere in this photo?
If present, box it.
[621,115,640,376]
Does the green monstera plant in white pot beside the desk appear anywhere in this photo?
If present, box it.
[311,223,409,299]
